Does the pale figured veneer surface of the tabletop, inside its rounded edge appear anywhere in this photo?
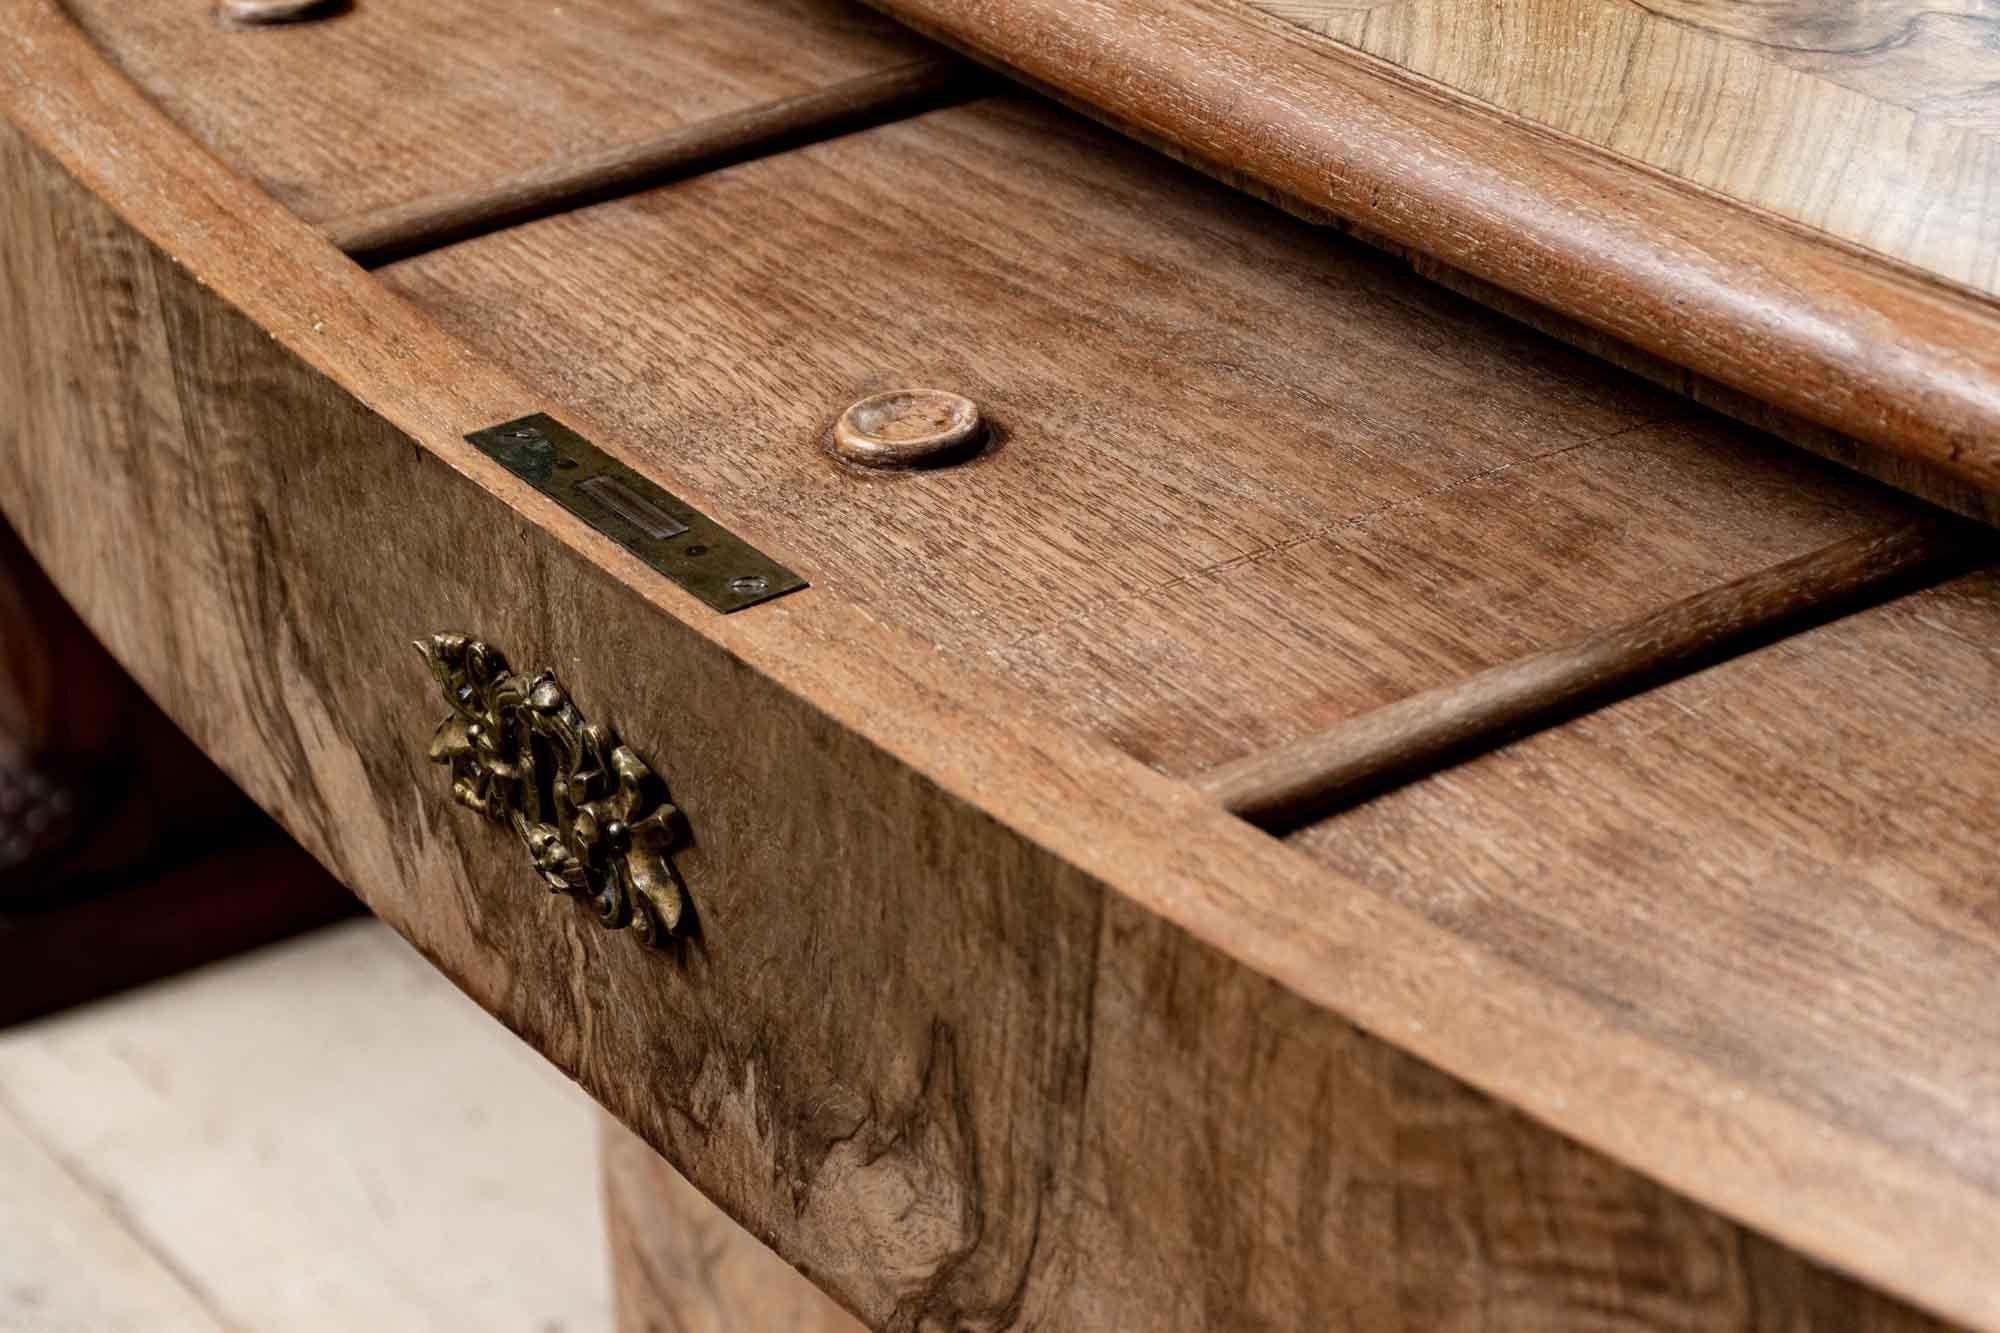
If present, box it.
[1244,0,2000,294]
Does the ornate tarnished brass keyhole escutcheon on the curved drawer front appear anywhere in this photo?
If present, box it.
[416,634,684,947]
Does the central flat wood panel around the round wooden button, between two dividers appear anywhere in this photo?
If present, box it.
[382,98,1902,773]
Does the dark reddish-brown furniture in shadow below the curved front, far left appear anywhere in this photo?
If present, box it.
[0,524,356,1025]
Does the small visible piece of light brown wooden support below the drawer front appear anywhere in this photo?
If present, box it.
[604,1117,862,1333]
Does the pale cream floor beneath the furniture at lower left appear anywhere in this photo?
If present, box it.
[0,921,612,1333]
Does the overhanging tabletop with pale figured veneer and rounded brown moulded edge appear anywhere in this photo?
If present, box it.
[878,0,2000,508]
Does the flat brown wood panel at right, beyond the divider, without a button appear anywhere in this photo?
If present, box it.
[1290,572,2000,1225]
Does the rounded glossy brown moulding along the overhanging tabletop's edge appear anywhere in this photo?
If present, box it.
[872,0,2000,490]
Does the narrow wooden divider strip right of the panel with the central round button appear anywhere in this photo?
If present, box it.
[1196,520,1972,829]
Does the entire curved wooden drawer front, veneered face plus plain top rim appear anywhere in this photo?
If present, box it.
[0,0,2000,1329]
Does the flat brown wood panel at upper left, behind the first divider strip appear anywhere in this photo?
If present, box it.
[64,0,930,224]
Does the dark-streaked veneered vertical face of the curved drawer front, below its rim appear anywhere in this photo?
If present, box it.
[31,116,1926,1331]
